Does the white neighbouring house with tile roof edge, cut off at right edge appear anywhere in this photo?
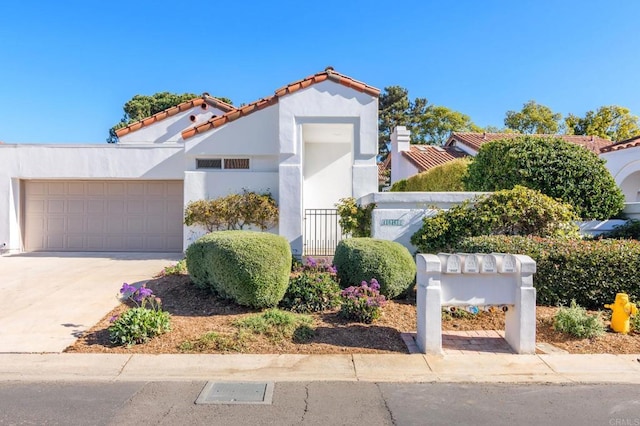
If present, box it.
[600,136,640,203]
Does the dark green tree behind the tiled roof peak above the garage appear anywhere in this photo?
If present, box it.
[107,92,232,143]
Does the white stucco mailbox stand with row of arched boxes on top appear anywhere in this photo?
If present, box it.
[416,253,536,354]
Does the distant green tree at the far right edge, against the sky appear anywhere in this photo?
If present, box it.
[564,105,640,142]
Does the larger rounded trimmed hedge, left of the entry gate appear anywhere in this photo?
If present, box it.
[187,231,291,308]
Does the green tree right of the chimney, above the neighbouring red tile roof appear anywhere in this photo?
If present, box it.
[411,105,482,145]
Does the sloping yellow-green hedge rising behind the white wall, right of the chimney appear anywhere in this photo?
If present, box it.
[391,158,471,192]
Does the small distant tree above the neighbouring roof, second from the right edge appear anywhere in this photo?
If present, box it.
[504,100,562,134]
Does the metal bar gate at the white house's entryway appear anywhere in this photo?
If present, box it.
[303,209,344,256]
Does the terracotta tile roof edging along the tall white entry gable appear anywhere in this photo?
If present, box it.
[182,67,380,139]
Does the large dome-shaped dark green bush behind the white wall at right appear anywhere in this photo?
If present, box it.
[464,136,624,219]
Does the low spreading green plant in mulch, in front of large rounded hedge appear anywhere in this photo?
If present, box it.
[233,309,313,341]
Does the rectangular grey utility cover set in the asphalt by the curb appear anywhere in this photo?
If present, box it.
[196,382,273,405]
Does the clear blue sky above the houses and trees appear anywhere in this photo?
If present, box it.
[0,0,640,143]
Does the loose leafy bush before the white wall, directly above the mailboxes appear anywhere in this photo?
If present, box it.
[411,186,578,253]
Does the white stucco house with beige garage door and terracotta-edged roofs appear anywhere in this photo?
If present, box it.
[0,68,379,255]
